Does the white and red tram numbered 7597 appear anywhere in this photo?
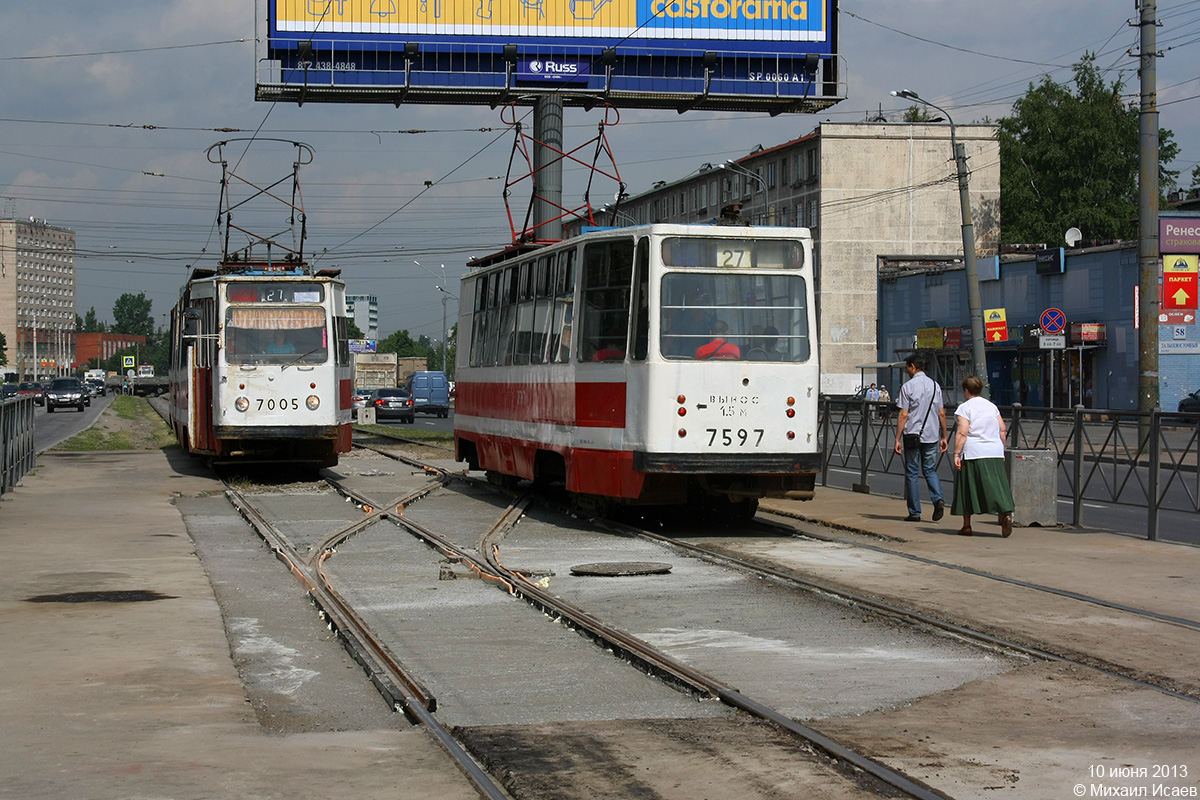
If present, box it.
[455,224,821,513]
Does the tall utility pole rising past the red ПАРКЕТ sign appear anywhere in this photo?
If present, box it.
[1138,0,1160,419]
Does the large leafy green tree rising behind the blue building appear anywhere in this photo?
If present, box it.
[996,53,1178,242]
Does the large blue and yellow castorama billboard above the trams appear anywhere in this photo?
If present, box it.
[256,0,844,113]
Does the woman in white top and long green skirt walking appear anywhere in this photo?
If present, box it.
[950,375,1013,537]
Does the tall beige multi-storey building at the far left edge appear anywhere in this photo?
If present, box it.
[0,218,76,380]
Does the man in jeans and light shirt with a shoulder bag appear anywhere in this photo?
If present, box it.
[895,355,948,522]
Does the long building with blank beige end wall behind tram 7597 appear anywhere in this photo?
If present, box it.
[572,122,1000,395]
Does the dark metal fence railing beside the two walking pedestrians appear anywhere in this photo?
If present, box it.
[820,397,1200,540]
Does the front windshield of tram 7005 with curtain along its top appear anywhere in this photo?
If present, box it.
[224,306,329,365]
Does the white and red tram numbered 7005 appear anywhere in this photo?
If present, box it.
[169,261,353,468]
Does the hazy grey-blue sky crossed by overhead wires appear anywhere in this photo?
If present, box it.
[0,0,1200,338]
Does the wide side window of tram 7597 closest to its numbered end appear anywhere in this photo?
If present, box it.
[578,239,634,361]
